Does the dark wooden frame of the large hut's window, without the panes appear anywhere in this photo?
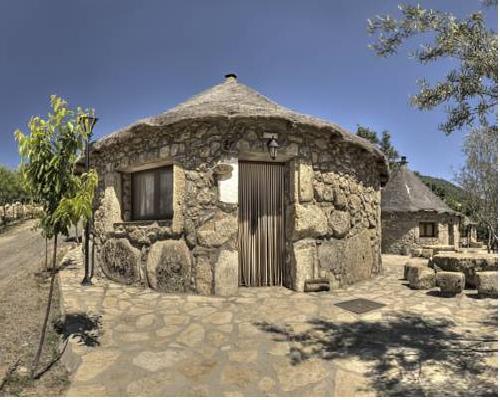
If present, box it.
[130,165,174,221]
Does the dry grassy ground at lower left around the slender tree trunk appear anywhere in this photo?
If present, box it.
[0,239,73,396]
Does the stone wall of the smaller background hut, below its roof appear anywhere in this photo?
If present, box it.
[382,211,460,255]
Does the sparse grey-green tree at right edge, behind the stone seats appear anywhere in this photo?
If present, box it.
[456,127,498,250]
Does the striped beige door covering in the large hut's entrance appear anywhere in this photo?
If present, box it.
[238,162,286,286]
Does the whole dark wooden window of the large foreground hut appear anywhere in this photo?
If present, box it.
[132,166,173,220]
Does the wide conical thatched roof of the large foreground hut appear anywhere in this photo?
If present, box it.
[94,75,387,180]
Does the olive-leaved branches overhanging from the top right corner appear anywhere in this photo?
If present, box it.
[368,0,498,134]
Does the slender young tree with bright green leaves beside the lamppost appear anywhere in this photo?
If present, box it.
[15,96,97,377]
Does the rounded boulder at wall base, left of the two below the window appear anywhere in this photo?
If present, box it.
[100,238,141,285]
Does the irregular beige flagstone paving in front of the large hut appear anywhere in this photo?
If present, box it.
[60,249,497,396]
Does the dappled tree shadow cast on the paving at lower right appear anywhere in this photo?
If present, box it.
[256,309,497,396]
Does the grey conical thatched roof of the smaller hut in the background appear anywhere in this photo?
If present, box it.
[381,163,459,215]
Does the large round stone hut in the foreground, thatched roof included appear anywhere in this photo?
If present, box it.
[91,74,388,295]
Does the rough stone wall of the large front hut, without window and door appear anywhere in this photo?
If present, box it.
[91,119,381,295]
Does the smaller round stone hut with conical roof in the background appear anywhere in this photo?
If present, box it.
[382,157,460,254]
